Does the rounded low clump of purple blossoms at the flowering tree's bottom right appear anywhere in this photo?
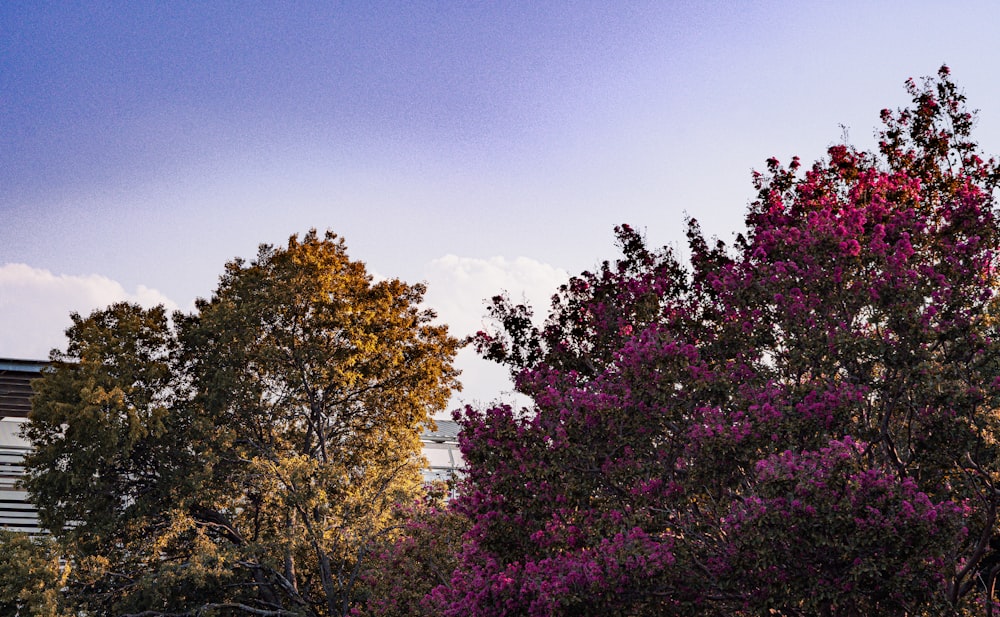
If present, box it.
[715,437,974,614]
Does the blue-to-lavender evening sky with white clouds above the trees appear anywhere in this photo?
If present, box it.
[0,0,1000,406]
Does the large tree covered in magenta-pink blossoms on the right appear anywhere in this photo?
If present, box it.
[444,68,1000,616]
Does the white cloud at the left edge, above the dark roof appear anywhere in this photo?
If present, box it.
[0,263,177,359]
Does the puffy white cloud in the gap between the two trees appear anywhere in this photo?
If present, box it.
[425,255,569,407]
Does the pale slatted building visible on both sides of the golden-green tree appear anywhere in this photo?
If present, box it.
[0,358,463,532]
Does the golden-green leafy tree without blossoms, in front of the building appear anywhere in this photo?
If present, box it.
[25,231,459,616]
